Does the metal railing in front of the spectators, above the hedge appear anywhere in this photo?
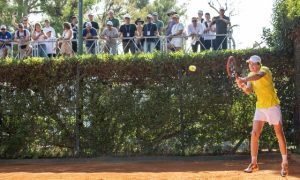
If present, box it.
[0,34,235,58]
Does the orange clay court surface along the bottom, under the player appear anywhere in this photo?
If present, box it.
[0,154,300,180]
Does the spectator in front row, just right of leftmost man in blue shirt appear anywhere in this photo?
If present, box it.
[14,23,32,59]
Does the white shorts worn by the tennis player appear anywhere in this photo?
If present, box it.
[253,105,282,125]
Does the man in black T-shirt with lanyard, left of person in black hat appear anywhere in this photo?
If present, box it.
[120,14,136,54]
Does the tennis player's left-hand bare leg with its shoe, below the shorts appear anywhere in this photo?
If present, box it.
[244,120,265,173]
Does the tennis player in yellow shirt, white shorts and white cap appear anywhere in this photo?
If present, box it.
[236,55,288,177]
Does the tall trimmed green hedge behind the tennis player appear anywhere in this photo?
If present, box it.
[0,49,294,158]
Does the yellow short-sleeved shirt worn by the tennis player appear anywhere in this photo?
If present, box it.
[248,66,280,108]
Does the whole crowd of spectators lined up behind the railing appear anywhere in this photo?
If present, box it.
[0,8,230,58]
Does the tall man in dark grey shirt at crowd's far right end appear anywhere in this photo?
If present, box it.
[210,7,230,50]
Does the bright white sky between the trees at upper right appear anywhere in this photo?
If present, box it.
[178,0,275,49]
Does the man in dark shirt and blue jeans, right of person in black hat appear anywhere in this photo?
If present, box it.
[143,14,158,53]
